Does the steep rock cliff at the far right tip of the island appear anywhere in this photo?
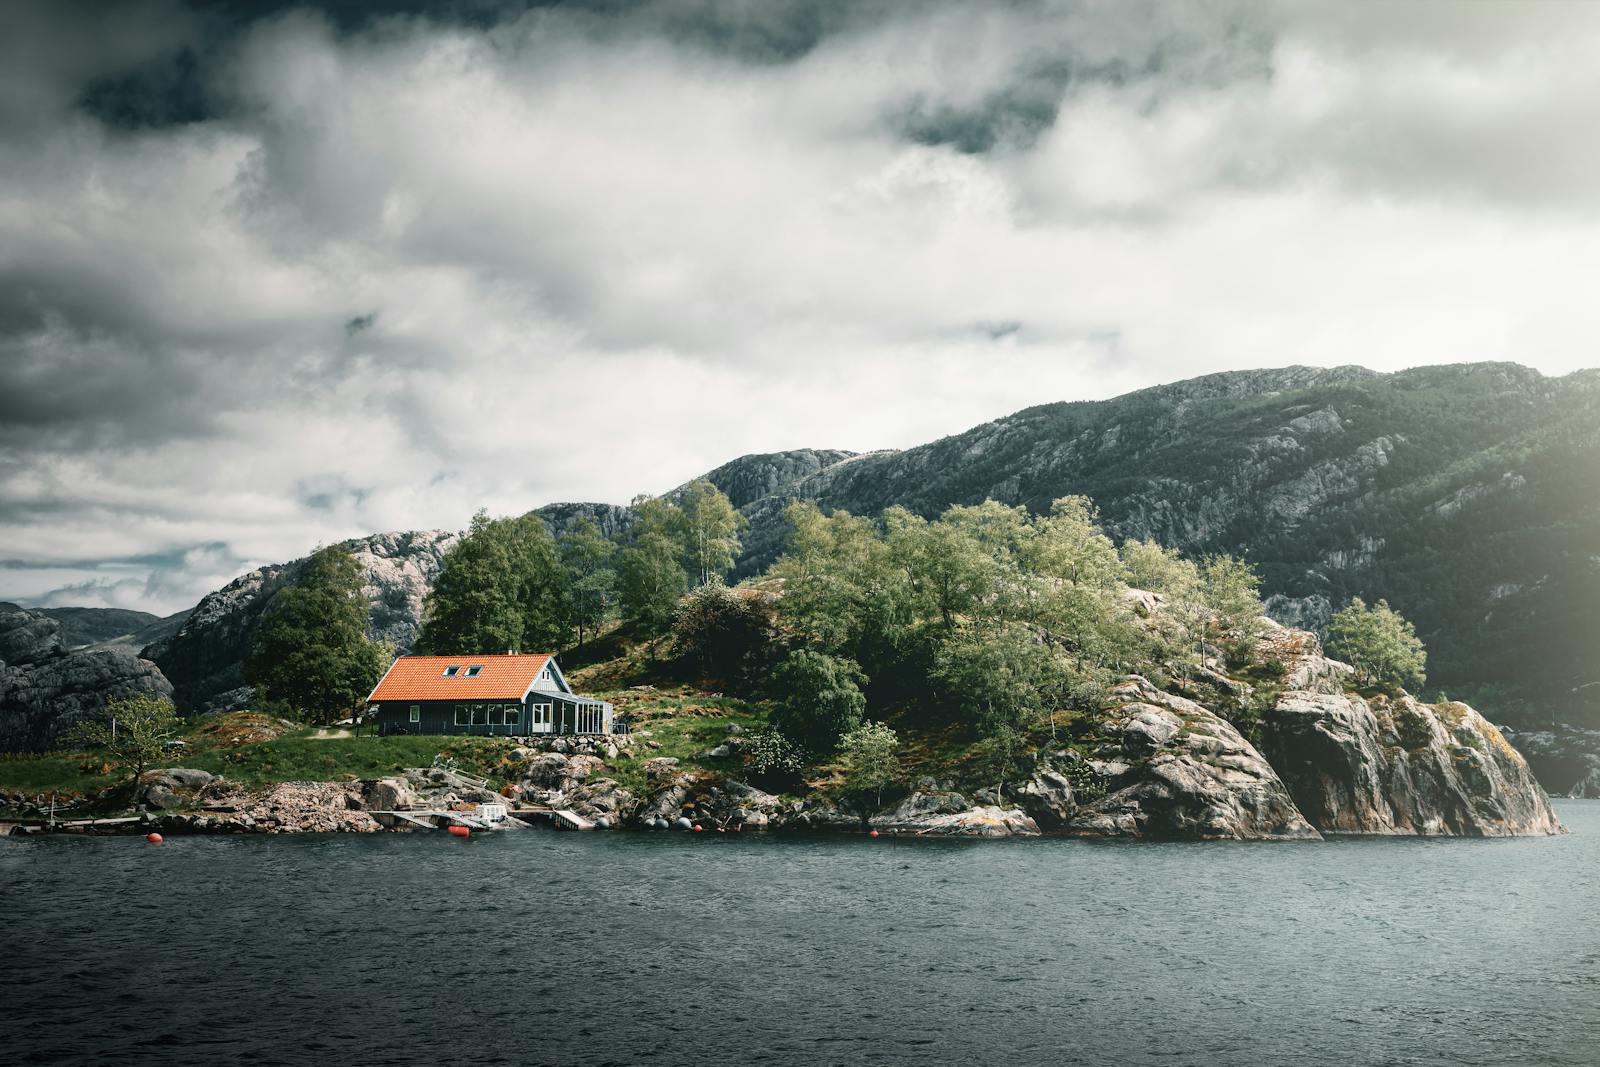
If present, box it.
[1264,689,1562,837]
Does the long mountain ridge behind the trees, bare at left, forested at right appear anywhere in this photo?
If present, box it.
[116,363,1600,721]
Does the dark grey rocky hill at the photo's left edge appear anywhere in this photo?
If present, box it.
[0,605,173,752]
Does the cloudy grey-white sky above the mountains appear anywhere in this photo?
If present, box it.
[0,0,1600,613]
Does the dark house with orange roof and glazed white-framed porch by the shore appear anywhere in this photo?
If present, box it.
[366,653,614,737]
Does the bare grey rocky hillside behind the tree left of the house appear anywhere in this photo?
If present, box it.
[142,530,458,710]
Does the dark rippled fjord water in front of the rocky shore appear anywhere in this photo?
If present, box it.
[0,801,1600,1065]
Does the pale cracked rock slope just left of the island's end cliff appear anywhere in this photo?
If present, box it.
[1049,677,1318,840]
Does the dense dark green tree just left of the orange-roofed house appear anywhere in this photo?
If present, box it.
[245,547,386,723]
